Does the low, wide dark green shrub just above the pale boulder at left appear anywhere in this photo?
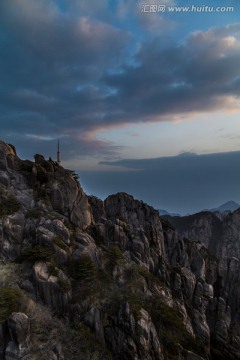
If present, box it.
[16,245,54,263]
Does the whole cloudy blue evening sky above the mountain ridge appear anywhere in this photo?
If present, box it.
[0,0,240,213]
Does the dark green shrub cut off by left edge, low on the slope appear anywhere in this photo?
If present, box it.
[0,287,22,324]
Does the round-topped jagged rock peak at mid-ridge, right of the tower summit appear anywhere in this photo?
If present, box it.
[92,193,165,270]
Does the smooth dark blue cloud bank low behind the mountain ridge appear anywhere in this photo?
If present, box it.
[79,151,240,213]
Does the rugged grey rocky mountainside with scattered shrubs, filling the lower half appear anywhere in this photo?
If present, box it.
[0,142,240,360]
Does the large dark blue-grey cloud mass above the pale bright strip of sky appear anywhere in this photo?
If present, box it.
[0,0,240,158]
